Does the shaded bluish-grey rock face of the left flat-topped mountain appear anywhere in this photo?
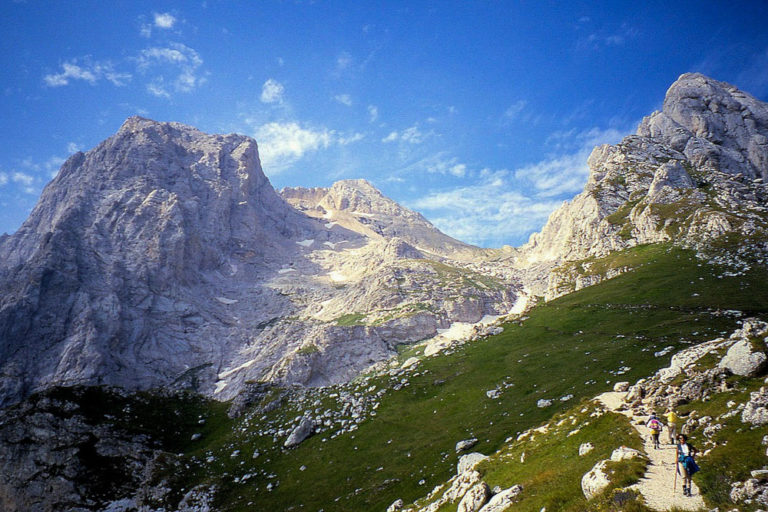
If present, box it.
[0,117,312,403]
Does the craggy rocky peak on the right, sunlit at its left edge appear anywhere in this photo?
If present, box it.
[516,73,768,286]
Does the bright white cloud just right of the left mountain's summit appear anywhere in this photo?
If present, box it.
[254,121,363,174]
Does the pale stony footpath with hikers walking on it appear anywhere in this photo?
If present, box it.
[597,392,706,511]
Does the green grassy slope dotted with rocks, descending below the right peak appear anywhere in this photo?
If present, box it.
[168,245,768,512]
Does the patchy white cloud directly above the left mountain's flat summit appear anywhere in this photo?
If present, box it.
[136,43,206,98]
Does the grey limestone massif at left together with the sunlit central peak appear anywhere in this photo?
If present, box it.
[0,117,514,404]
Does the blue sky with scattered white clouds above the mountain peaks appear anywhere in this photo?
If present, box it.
[0,0,768,247]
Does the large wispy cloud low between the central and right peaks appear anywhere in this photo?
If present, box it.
[408,128,626,247]
